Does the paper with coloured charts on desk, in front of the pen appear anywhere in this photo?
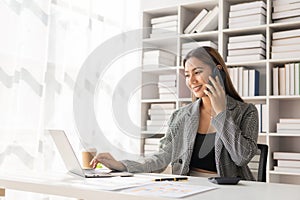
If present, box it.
[121,181,216,198]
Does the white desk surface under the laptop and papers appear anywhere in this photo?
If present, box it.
[0,170,300,200]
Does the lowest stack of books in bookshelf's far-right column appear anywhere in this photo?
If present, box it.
[273,152,300,173]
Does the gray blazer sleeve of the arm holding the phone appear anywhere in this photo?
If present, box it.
[212,104,258,166]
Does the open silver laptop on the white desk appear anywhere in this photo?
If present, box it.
[48,130,133,178]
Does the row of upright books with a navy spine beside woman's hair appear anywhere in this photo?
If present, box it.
[228,67,260,97]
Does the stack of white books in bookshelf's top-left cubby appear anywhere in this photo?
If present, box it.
[150,15,178,38]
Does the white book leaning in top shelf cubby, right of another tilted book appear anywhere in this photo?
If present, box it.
[192,6,219,33]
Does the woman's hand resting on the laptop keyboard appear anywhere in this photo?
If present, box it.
[90,153,126,171]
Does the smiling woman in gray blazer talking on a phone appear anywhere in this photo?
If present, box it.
[91,47,258,180]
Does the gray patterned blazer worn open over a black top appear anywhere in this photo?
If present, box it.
[121,96,258,180]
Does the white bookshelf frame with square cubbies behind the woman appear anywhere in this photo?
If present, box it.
[141,0,300,184]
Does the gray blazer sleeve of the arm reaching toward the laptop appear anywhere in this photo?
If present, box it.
[120,111,178,173]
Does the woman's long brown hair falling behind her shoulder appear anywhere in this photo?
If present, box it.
[183,46,244,102]
